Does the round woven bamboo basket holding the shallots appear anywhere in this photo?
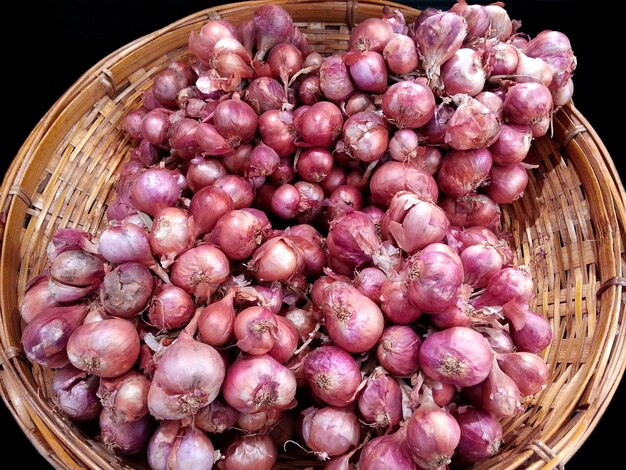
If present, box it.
[0,0,626,469]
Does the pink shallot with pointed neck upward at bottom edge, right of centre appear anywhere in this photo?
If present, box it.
[406,390,461,469]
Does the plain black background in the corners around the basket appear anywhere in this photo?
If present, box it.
[0,0,626,470]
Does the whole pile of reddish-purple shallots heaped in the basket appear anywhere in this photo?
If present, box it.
[21,0,576,470]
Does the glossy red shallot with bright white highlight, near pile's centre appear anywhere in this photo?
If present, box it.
[248,237,304,282]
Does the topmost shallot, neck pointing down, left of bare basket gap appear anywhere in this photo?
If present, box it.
[253,5,294,60]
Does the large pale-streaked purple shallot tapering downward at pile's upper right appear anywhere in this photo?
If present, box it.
[414,12,467,80]
